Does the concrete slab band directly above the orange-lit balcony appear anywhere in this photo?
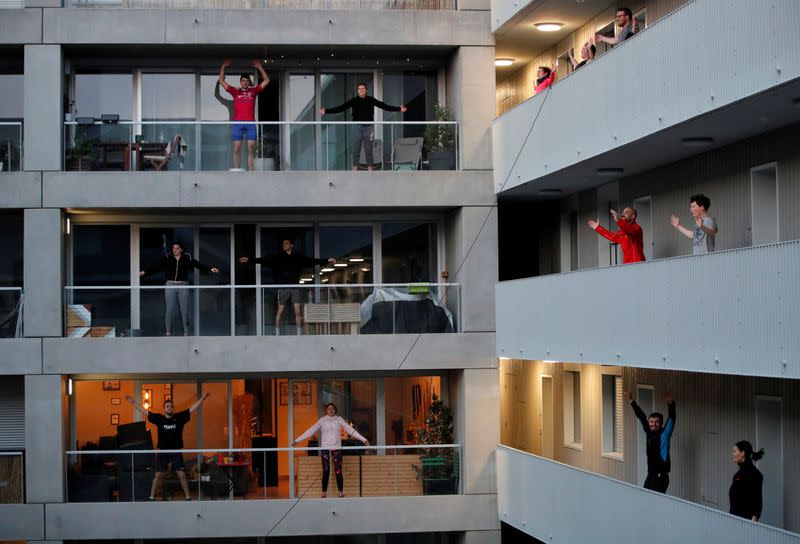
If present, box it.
[43,333,497,374]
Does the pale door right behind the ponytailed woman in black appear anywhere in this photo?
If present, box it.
[753,397,783,527]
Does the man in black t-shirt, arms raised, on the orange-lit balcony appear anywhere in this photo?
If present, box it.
[125,392,210,501]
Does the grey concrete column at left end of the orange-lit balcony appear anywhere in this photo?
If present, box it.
[25,374,67,503]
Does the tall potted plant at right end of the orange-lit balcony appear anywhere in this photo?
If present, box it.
[414,395,458,495]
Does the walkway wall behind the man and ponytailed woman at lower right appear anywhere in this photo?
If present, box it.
[499,360,800,532]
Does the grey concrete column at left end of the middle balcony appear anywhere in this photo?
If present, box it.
[23,208,64,337]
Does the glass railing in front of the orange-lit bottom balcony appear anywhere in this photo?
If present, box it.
[66,444,462,502]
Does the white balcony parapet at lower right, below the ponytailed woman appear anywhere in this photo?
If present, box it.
[497,446,800,544]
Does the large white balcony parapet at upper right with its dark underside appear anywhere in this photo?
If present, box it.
[493,0,800,194]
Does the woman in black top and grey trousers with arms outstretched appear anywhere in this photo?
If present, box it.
[139,242,219,336]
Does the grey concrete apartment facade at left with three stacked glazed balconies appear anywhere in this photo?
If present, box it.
[0,0,500,543]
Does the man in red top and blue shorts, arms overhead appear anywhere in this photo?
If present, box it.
[219,59,269,170]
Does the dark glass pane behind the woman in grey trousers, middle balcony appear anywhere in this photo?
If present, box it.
[139,227,195,336]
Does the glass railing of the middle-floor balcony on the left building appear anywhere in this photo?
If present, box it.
[64,283,461,338]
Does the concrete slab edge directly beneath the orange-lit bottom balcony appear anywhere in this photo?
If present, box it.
[46,491,496,544]
